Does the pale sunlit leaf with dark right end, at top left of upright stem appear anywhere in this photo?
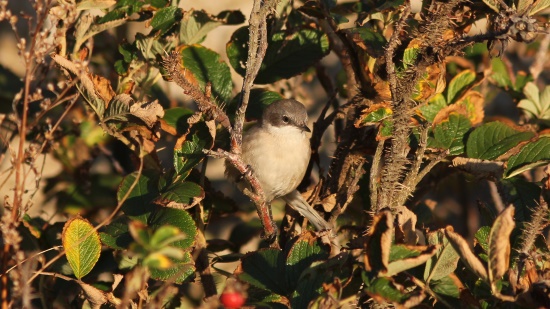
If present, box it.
[179,9,245,45]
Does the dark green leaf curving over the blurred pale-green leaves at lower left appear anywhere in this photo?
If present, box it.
[148,207,197,250]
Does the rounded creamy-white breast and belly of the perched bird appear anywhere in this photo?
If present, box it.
[242,125,311,201]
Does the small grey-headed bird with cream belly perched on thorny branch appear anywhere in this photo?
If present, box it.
[226,99,331,230]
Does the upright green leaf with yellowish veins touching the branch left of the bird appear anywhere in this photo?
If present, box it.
[174,122,212,178]
